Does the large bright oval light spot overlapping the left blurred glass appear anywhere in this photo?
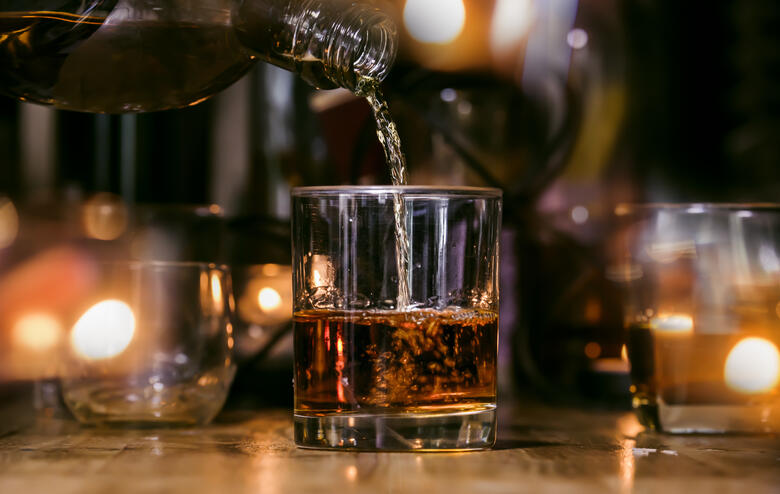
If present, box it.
[70,300,135,360]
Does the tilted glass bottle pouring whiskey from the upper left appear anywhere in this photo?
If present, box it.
[0,0,397,113]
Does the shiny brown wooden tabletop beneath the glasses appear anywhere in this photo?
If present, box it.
[0,406,780,494]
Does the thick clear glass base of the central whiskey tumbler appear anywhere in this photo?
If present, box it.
[294,408,496,451]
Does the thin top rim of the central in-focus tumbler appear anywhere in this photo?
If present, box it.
[291,185,504,198]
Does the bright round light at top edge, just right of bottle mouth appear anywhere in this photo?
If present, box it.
[404,0,466,45]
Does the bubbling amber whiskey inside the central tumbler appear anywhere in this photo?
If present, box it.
[294,310,498,415]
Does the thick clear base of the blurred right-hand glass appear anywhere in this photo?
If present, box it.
[636,400,780,434]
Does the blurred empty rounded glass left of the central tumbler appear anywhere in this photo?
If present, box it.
[61,262,235,425]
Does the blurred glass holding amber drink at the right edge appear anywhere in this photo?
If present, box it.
[612,204,780,433]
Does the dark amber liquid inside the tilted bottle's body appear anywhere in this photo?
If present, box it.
[0,12,254,113]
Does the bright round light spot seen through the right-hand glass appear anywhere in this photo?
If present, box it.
[723,337,780,394]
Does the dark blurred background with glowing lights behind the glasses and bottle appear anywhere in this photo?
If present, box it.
[0,0,780,407]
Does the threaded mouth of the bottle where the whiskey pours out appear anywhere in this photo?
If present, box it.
[328,5,398,91]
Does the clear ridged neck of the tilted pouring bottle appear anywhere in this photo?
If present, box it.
[233,0,398,91]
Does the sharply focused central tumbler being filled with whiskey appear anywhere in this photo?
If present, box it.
[293,186,501,451]
